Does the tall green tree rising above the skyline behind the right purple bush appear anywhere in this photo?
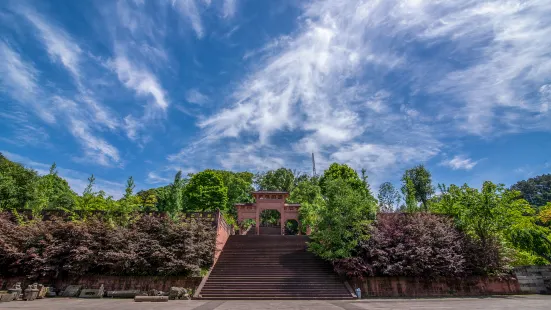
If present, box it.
[402,165,434,211]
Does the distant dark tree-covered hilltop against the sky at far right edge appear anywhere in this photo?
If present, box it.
[511,174,551,207]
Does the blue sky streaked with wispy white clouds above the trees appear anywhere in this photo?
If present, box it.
[0,0,551,196]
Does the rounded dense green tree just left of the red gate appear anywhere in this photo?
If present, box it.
[184,171,228,211]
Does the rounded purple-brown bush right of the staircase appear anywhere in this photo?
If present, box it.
[334,213,508,278]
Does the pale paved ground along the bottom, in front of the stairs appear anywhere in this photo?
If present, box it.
[0,295,551,310]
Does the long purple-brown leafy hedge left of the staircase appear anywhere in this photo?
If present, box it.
[0,213,215,278]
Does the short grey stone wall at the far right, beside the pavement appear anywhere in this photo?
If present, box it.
[514,266,551,294]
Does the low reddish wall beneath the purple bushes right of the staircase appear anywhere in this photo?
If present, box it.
[349,277,521,298]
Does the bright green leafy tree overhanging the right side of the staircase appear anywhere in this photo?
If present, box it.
[309,178,377,260]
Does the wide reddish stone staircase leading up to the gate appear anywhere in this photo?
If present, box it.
[198,235,352,299]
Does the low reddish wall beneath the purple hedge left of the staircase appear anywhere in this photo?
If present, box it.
[0,276,202,291]
